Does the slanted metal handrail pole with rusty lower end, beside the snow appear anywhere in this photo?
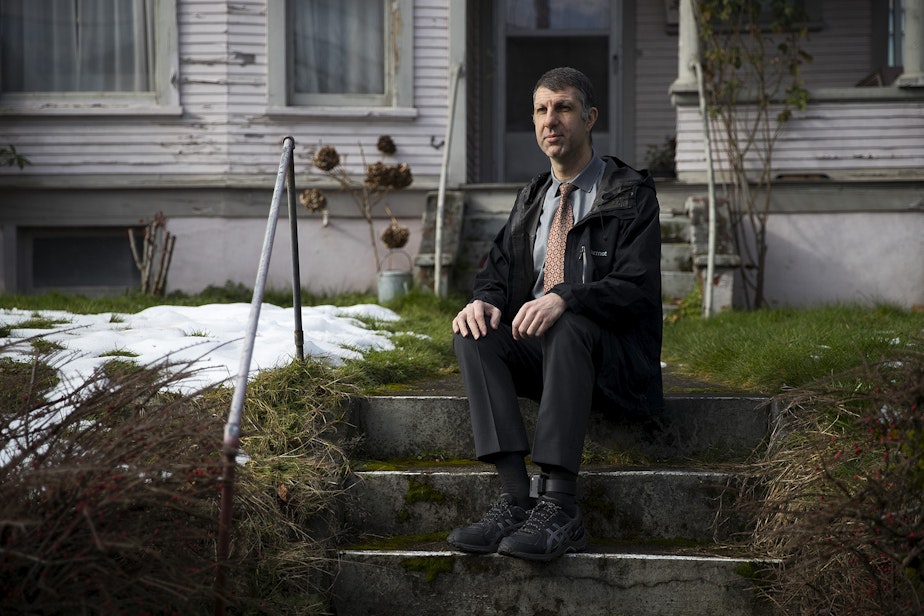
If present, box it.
[214,137,295,616]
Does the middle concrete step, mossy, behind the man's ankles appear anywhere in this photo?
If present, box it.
[345,464,746,543]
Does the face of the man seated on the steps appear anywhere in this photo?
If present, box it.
[533,87,597,163]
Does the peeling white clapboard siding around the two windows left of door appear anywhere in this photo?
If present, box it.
[0,0,449,184]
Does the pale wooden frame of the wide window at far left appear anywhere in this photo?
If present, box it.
[0,0,182,115]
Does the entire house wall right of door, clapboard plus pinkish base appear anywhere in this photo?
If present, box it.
[672,0,924,307]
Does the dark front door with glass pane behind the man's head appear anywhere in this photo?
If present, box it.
[498,0,622,183]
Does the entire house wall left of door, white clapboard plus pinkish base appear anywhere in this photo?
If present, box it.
[0,0,452,292]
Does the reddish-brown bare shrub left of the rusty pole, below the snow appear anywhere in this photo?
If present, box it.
[0,348,221,613]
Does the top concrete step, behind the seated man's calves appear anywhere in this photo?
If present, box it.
[349,395,774,462]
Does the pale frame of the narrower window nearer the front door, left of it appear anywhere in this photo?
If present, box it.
[266,0,416,117]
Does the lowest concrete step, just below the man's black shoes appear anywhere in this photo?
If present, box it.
[334,546,772,616]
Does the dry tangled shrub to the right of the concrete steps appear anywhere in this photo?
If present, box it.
[755,340,924,616]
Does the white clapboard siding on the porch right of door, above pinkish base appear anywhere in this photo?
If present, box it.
[676,0,924,182]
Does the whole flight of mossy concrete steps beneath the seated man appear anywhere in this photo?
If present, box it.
[332,395,775,616]
